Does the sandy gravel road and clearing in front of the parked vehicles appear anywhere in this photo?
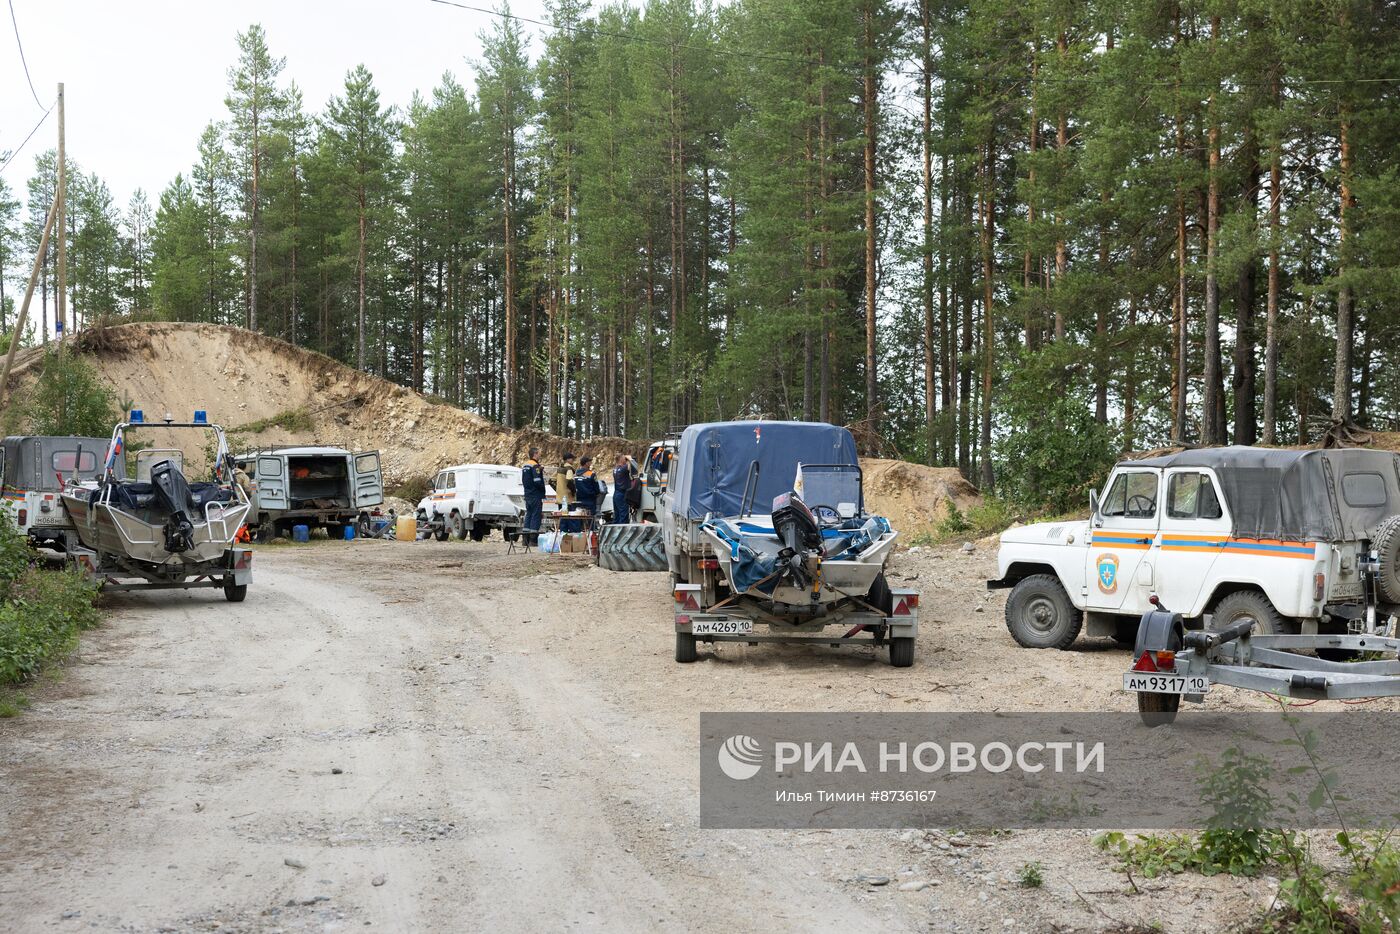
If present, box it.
[0,542,1366,931]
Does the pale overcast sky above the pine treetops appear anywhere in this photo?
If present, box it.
[0,0,547,209]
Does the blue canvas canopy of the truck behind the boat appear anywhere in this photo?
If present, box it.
[668,421,858,520]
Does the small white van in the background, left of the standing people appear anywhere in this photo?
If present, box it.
[417,463,559,542]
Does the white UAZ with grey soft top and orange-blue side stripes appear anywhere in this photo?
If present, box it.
[987,447,1400,648]
